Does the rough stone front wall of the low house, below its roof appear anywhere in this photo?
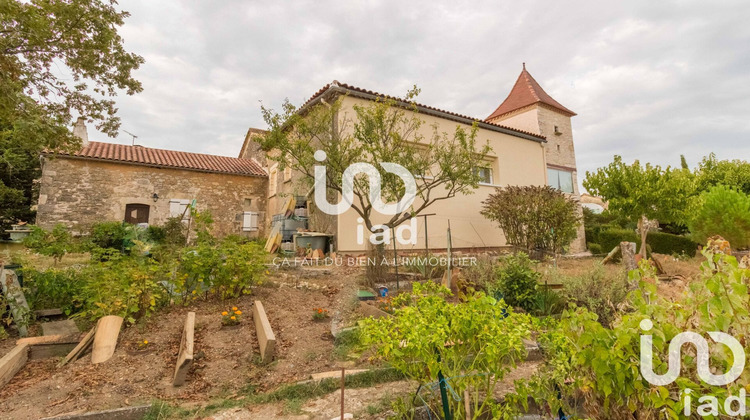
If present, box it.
[37,157,268,237]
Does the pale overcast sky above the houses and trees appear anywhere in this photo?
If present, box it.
[92,0,750,187]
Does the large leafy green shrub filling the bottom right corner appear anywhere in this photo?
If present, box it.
[507,241,750,420]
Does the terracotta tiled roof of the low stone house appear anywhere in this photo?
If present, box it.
[47,141,268,177]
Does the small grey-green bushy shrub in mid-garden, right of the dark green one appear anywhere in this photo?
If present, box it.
[551,263,628,326]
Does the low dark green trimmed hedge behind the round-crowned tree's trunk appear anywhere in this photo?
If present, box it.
[596,229,698,256]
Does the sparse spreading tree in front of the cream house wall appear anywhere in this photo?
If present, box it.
[259,87,491,279]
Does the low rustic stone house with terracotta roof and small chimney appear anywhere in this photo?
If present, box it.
[37,120,268,237]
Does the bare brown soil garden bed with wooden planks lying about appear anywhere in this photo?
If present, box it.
[0,275,354,419]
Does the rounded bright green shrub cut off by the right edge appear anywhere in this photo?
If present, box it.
[688,185,750,249]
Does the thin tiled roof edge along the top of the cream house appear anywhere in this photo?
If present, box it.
[300,80,546,141]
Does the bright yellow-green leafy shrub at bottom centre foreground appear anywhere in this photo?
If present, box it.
[359,282,531,418]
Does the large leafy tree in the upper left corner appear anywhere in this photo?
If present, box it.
[0,0,143,235]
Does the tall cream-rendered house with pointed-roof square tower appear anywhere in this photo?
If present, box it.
[240,65,586,253]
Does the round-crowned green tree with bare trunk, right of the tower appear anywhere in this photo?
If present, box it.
[583,156,695,257]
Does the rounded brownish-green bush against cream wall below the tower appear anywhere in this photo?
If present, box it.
[482,185,580,255]
